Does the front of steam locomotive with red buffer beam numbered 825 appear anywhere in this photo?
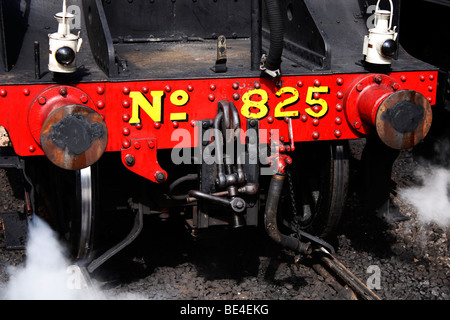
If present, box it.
[0,0,438,272]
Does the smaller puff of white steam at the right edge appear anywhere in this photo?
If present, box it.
[399,167,450,228]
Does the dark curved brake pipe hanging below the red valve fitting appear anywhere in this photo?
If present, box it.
[264,173,312,254]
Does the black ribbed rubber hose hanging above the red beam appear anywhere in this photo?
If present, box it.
[265,0,284,71]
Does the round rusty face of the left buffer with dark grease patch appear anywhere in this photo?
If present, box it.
[41,105,108,170]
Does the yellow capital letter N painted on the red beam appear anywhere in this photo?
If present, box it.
[129,91,164,124]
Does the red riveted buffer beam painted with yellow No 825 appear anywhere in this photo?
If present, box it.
[0,71,437,181]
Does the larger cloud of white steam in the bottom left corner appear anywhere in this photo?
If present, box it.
[0,217,142,300]
